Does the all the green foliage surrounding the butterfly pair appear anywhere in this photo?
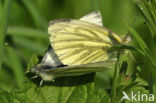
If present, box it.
[0,0,156,103]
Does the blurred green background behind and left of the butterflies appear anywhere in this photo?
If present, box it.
[0,0,148,90]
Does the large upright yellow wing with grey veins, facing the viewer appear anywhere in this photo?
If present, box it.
[48,19,122,66]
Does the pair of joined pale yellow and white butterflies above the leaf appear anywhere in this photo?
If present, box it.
[29,11,129,85]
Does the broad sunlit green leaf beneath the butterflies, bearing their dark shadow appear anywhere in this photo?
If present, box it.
[2,54,110,103]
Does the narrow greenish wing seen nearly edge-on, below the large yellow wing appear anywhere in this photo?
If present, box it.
[45,60,116,77]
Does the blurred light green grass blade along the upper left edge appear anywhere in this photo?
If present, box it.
[0,0,12,68]
